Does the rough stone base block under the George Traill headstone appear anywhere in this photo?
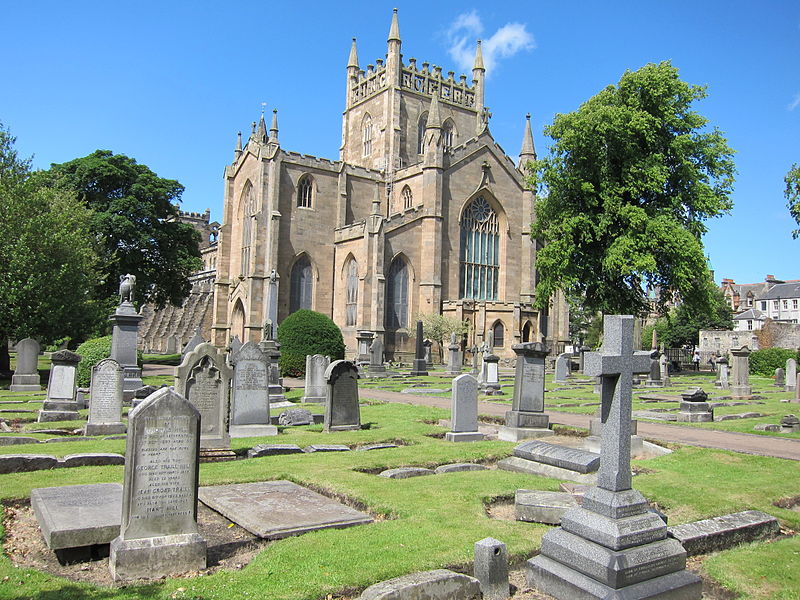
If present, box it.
[108,533,207,581]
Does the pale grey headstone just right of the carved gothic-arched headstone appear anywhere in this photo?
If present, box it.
[228,338,278,437]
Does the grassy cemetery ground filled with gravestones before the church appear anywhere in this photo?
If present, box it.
[0,317,800,599]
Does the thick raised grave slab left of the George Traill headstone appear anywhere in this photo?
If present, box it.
[31,483,122,550]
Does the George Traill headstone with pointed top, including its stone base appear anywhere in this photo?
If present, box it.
[108,388,206,580]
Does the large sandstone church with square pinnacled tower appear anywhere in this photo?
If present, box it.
[212,10,568,359]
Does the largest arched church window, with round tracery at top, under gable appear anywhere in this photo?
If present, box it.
[460,196,500,300]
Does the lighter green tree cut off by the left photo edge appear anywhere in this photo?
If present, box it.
[0,125,97,370]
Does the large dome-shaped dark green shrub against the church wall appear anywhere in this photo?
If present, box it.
[278,309,344,377]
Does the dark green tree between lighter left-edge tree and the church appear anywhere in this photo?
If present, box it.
[42,150,202,306]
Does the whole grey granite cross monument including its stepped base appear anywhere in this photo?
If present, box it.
[527,315,702,600]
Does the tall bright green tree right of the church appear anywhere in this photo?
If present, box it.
[529,62,735,313]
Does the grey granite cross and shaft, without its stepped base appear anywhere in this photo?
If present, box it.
[585,315,650,492]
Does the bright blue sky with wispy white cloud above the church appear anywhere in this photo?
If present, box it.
[0,0,800,283]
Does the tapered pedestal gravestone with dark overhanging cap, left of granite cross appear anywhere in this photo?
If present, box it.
[498,342,553,442]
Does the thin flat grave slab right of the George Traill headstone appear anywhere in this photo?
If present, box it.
[199,481,372,540]
